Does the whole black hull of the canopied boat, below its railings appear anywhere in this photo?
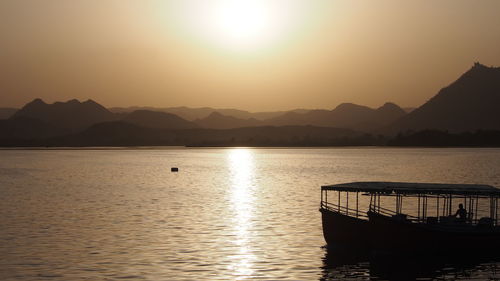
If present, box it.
[320,208,500,255]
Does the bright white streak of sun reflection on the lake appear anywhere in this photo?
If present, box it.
[228,148,256,279]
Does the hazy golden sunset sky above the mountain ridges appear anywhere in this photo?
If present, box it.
[0,0,500,111]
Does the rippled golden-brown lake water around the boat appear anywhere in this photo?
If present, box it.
[0,148,500,280]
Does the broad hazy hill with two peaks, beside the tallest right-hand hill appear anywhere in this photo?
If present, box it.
[266,103,406,131]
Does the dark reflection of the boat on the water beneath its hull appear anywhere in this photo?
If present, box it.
[320,244,500,281]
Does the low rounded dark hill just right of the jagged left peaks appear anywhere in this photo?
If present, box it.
[122,110,199,129]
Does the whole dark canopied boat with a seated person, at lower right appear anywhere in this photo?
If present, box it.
[320,182,500,254]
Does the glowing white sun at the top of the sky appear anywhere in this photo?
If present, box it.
[176,0,304,50]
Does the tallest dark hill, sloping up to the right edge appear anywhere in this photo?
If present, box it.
[384,63,500,134]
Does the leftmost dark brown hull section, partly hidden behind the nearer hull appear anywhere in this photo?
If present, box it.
[320,208,370,249]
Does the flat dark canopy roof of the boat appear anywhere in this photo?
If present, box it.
[321,182,500,197]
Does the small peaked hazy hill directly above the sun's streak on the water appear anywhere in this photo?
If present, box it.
[195,112,262,129]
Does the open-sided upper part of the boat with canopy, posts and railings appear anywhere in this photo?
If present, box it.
[321,182,500,228]
